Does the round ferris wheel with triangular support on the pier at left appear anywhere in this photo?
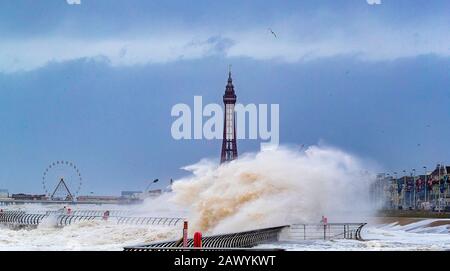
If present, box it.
[42,160,83,201]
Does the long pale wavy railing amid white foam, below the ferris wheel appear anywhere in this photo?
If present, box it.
[0,211,184,227]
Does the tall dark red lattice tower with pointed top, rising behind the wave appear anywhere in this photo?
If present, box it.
[220,69,237,163]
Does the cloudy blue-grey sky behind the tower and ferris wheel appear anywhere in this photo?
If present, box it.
[0,0,450,194]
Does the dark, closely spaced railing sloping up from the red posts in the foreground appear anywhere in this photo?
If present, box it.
[124,226,287,251]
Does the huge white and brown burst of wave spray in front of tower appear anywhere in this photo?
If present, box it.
[172,146,373,233]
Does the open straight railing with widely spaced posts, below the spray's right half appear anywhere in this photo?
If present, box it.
[287,223,366,241]
